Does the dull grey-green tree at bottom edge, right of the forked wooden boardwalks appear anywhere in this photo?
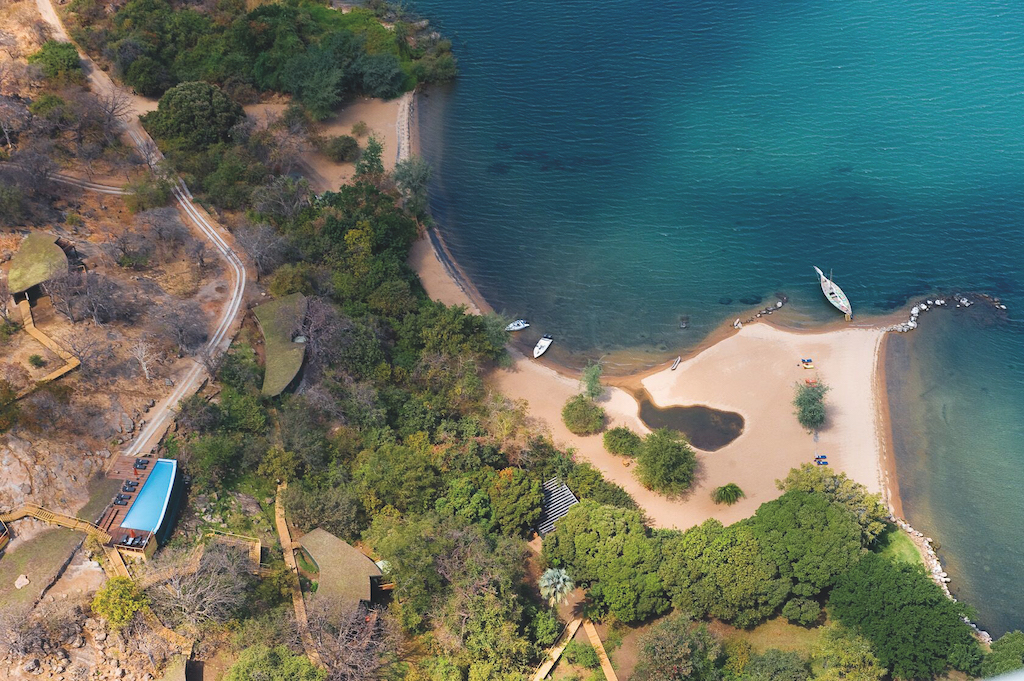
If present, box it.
[632,614,722,681]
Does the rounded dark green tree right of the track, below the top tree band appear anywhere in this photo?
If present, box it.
[142,81,245,152]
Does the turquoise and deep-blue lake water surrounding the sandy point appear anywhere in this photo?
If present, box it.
[417,0,1024,634]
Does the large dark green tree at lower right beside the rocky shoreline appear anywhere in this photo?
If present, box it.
[827,552,978,679]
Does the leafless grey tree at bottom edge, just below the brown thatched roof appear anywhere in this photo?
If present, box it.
[308,596,398,681]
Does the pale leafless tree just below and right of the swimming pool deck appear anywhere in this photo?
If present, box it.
[146,543,251,629]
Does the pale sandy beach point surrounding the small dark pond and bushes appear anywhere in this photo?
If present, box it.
[488,324,884,529]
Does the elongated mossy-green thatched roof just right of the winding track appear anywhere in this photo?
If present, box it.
[253,293,306,397]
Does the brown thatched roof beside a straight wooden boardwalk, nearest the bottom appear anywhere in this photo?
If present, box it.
[299,527,381,610]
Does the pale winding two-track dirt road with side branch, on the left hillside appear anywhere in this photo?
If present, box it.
[27,0,248,463]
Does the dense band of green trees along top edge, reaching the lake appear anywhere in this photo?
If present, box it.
[71,0,456,105]
